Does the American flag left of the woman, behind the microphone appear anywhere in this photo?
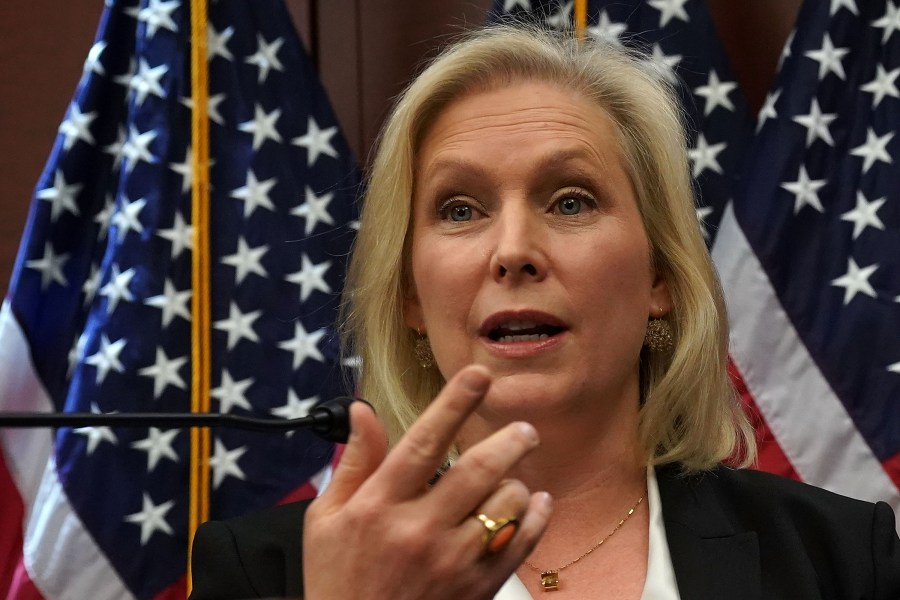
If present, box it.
[0,0,359,600]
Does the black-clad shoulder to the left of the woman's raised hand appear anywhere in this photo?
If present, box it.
[191,500,311,600]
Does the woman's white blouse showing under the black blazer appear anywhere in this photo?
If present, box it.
[494,467,681,600]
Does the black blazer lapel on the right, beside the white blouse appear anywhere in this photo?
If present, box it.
[657,466,761,600]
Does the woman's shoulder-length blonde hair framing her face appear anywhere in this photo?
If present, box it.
[342,25,755,471]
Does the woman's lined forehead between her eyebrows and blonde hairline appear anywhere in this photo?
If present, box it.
[416,81,621,173]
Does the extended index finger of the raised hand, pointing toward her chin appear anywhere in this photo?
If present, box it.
[370,365,491,500]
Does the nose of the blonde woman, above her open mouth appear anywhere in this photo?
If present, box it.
[491,208,548,283]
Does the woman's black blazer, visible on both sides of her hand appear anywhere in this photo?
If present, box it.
[191,467,900,600]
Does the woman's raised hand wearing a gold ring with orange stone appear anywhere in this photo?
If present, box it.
[303,366,551,600]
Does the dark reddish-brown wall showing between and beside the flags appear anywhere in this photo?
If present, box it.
[0,0,801,294]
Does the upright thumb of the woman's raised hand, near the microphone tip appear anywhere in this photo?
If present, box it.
[319,402,387,507]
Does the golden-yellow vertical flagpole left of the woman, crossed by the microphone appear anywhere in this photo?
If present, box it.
[187,0,210,595]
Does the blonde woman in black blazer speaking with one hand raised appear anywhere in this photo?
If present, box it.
[193,27,900,600]
